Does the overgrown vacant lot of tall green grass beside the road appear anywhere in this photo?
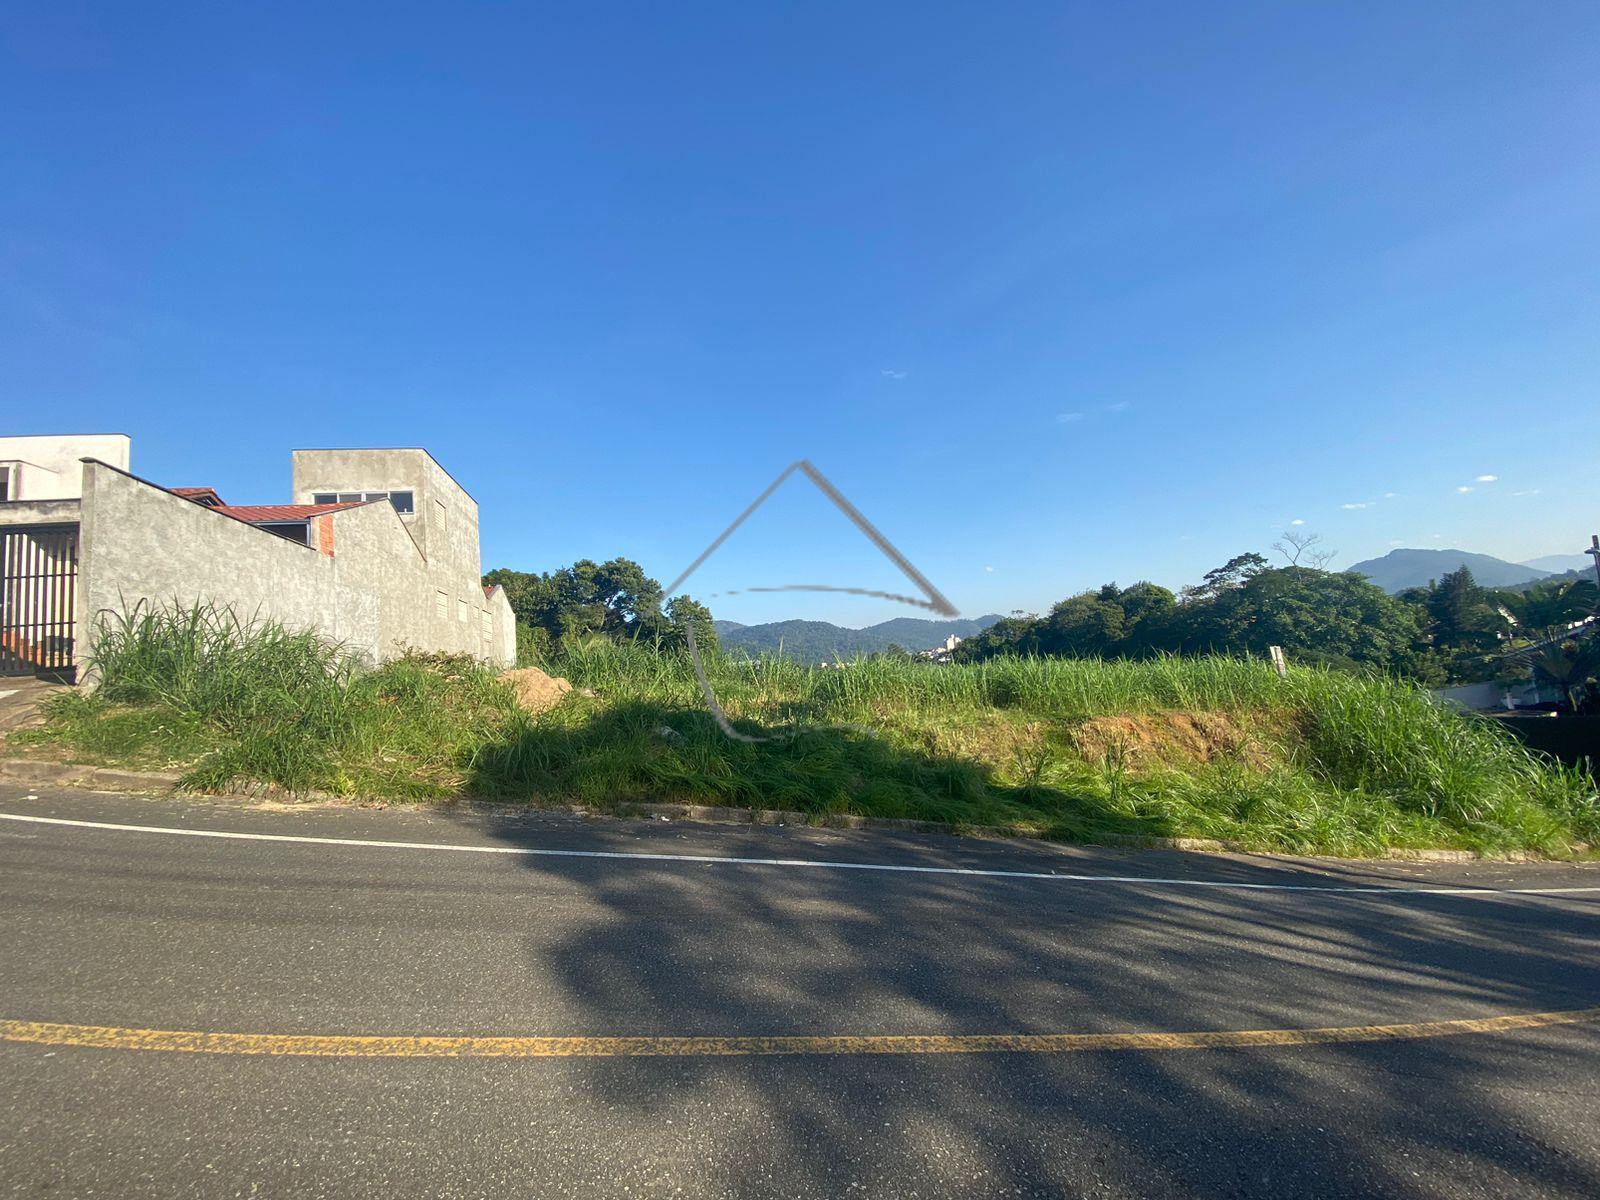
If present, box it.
[15,611,1600,854]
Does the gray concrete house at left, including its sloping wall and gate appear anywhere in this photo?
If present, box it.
[0,434,517,675]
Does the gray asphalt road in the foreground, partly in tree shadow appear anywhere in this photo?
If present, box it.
[0,786,1600,1198]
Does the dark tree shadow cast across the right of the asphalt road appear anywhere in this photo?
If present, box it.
[459,712,1600,1197]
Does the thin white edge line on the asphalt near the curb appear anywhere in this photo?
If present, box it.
[0,813,1600,896]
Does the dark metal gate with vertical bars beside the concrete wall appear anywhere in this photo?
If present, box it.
[0,525,78,675]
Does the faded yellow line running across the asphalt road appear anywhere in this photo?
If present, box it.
[0,1008,1600,1058]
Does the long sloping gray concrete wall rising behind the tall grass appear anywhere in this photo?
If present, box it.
[77,462,515,666]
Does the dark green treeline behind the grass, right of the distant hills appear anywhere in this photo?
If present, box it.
[957,554,1600,686]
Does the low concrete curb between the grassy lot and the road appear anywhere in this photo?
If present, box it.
[0,758,1584,862]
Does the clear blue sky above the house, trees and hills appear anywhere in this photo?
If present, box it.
[0,3,1600,624]
